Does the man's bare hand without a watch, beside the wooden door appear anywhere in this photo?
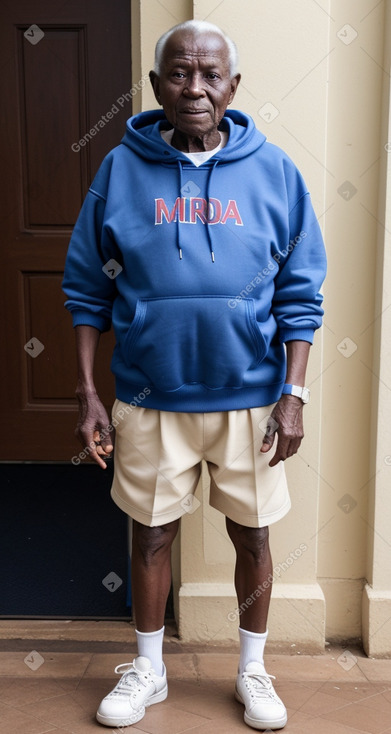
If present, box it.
[75,387,114,469]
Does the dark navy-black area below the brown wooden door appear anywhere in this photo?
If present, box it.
[0,464,130,619]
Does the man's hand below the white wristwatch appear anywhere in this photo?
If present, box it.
[261,395,304,466]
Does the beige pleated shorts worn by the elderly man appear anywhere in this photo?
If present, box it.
[111,400,290,528]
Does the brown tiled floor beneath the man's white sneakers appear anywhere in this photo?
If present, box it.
[0,640,391,734]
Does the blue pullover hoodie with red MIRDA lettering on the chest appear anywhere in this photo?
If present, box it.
[63,110,325,412]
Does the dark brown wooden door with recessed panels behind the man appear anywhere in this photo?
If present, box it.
[0,0,132,461]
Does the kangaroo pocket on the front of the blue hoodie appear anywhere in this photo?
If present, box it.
[122,296,266,392]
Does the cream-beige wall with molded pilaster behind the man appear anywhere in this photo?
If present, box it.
[132,0,391,655]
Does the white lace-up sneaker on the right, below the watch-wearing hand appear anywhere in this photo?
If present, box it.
[235,663,287,729]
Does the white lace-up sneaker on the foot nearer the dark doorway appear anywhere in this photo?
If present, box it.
[96,656,167,727]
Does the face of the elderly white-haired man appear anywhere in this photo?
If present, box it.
[150,31,240,137]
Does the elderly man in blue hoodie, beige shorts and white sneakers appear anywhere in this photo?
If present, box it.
[64,21,325,729]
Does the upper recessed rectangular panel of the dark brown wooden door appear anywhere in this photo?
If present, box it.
[18,24,87,230]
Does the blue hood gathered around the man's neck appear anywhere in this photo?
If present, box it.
[121,110,266,163]
